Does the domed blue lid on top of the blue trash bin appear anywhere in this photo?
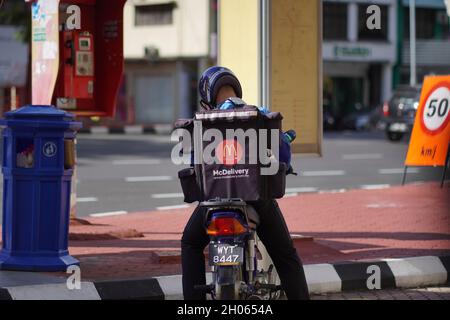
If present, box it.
[5,105,75,120]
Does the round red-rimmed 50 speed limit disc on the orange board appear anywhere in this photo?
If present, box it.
[421,83,450,135]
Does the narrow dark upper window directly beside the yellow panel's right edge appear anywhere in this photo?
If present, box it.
[323,2,347,40]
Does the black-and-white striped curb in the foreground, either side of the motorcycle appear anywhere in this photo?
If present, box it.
[0,255,450,300]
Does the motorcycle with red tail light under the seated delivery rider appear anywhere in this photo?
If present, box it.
[195,130,295,300]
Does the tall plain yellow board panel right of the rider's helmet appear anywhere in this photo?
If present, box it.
[270,0,322,154]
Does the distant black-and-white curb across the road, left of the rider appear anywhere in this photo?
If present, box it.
[78,124,173,135]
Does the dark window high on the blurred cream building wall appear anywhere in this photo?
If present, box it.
[134,2,175,26]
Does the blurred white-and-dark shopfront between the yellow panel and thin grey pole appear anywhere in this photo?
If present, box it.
[323,0,397,120]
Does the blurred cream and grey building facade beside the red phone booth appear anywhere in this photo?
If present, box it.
[118,0,215,124]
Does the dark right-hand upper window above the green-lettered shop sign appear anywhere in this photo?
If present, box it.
[358,5,389,41]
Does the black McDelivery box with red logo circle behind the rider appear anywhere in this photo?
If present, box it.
[175,106,286,203]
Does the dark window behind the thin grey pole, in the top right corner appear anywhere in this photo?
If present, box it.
[403,7,450,39]
